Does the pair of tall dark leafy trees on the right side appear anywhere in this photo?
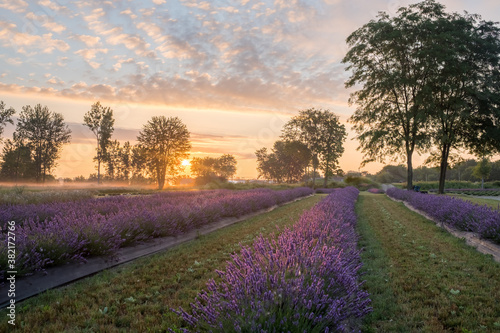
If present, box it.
[343,0,500,193]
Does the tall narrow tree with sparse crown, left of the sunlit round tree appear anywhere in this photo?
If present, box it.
[83,102,115,184]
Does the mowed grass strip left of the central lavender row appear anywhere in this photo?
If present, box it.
[0,195,324,332]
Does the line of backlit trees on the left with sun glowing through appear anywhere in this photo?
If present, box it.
[0,101,236,189]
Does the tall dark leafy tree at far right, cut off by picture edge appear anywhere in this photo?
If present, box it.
[424,7,500,193]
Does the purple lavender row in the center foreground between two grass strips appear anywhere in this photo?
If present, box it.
[170,187,371,332]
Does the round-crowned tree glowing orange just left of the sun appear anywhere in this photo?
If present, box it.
[137,116,191,190]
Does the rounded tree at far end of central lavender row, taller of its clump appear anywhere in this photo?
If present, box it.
[281,108,347,187]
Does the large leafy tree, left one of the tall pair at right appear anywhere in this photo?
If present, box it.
[343,1,443,189]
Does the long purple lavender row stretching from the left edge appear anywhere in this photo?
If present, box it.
[0,188,312,277]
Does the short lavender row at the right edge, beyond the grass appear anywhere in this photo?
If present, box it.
[386,188,500,244]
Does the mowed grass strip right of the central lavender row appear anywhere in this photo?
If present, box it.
[356,193,500,332]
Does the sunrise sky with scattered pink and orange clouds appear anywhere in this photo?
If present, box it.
[0,0,500,178]
